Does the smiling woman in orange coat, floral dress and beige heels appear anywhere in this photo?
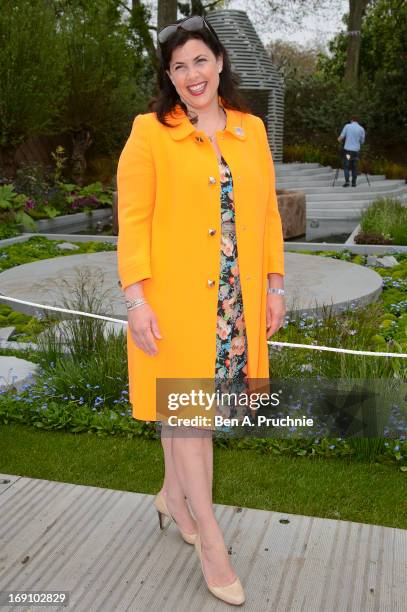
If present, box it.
[117,16,285,605]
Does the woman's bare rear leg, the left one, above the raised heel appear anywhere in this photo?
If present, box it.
[161,423,197,533]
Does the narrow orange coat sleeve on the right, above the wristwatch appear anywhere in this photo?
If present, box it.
[258,117,285,275]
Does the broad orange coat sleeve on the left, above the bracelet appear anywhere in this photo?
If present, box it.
[117,115,156,289]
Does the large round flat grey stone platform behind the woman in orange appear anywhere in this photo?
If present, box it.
[0,251,382,319]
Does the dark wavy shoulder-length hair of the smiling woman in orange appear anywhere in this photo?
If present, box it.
[148,15,250,127]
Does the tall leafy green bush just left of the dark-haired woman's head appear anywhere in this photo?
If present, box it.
[57,0,154,157]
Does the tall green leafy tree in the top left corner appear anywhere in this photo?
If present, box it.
[0,0,67,148]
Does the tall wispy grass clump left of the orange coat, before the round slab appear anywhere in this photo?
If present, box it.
[37,269,127,405]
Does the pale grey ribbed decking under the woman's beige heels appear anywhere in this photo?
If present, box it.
[0,474,407,612]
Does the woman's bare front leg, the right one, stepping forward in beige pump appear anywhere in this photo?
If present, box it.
[172,427,236,586]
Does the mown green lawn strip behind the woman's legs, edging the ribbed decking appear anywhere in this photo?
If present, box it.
[0,424,407,529]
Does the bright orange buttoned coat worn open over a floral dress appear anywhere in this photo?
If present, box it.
[117,100,284,421]
